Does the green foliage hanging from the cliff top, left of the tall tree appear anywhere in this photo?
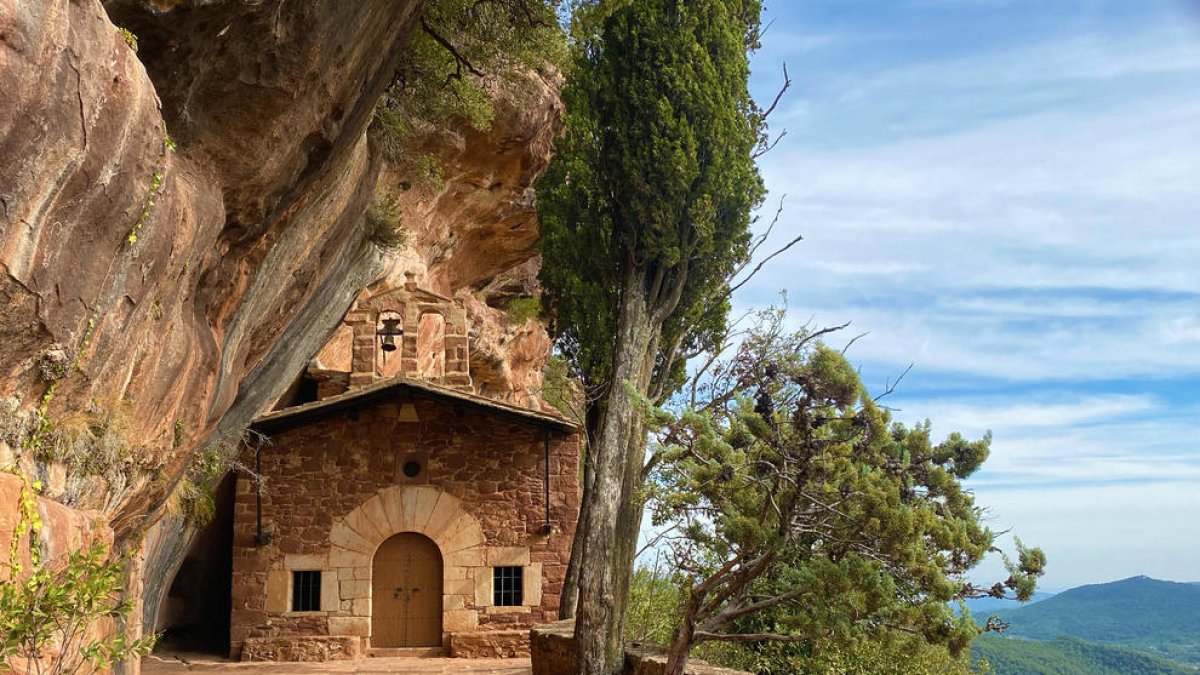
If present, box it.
[374,0,565,165]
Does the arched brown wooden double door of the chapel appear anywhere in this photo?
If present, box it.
[371,532,442,647]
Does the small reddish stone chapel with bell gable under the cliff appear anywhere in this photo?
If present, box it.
[228,280,580,661]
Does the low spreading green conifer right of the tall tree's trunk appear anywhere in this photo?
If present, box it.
[653,310,1045,655]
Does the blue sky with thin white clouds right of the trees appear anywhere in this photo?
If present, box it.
[737,0,1200,590]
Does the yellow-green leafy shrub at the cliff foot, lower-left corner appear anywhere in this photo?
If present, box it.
[0,472,155,674]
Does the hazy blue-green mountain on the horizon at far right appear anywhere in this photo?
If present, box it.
[980,577,1200,665]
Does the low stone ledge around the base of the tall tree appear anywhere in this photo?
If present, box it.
[529,619,750,675]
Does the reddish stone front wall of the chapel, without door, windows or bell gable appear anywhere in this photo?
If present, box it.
[230,389,580,659]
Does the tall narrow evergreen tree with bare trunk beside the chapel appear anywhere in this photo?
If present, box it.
[538,0,763,674]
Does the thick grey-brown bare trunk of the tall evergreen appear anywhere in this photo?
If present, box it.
[575,265,658,675]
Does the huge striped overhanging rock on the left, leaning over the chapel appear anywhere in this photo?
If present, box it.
[0,0,420,521]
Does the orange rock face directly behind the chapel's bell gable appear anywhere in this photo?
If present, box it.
[319,72,563,408]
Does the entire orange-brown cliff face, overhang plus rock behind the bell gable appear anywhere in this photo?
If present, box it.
[0,0,560,653]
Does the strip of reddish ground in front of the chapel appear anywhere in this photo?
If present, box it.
[142,652,533,675]
